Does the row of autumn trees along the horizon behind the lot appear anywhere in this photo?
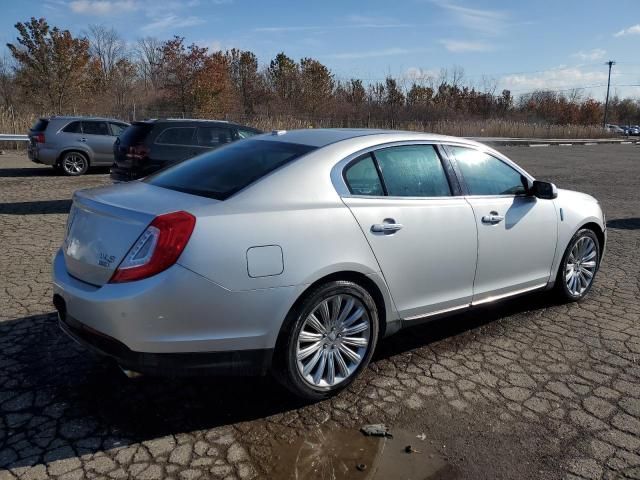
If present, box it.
[0,18,640,126]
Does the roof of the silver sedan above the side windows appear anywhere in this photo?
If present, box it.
[257,128,479,148]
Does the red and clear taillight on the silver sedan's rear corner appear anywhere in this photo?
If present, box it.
[109,212,196,283]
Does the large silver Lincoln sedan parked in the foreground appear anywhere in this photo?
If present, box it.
[53,129,606,399]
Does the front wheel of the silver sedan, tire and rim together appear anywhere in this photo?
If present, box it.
[555,228,600,302]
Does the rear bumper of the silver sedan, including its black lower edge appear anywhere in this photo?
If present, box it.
[53,251,300,374]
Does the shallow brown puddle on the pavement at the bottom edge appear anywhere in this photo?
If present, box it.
[269,428,458,480]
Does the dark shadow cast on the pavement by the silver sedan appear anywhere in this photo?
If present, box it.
[0,295,552,470]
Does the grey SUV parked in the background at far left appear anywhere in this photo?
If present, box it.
[27,116,129,176]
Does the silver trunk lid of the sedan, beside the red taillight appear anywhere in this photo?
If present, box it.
[62,182,217,286]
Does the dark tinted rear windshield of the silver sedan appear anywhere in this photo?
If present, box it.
[144,139,316,200]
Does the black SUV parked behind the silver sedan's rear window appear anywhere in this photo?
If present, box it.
[111,118,262,182]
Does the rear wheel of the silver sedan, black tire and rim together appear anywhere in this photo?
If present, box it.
[273,280,379,401]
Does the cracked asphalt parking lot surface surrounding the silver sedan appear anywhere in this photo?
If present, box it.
[0,145,640,480]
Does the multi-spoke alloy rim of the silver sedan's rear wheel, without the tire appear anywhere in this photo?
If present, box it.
[296,294,371,388]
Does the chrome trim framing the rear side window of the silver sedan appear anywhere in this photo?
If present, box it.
[331,140,463,200]
